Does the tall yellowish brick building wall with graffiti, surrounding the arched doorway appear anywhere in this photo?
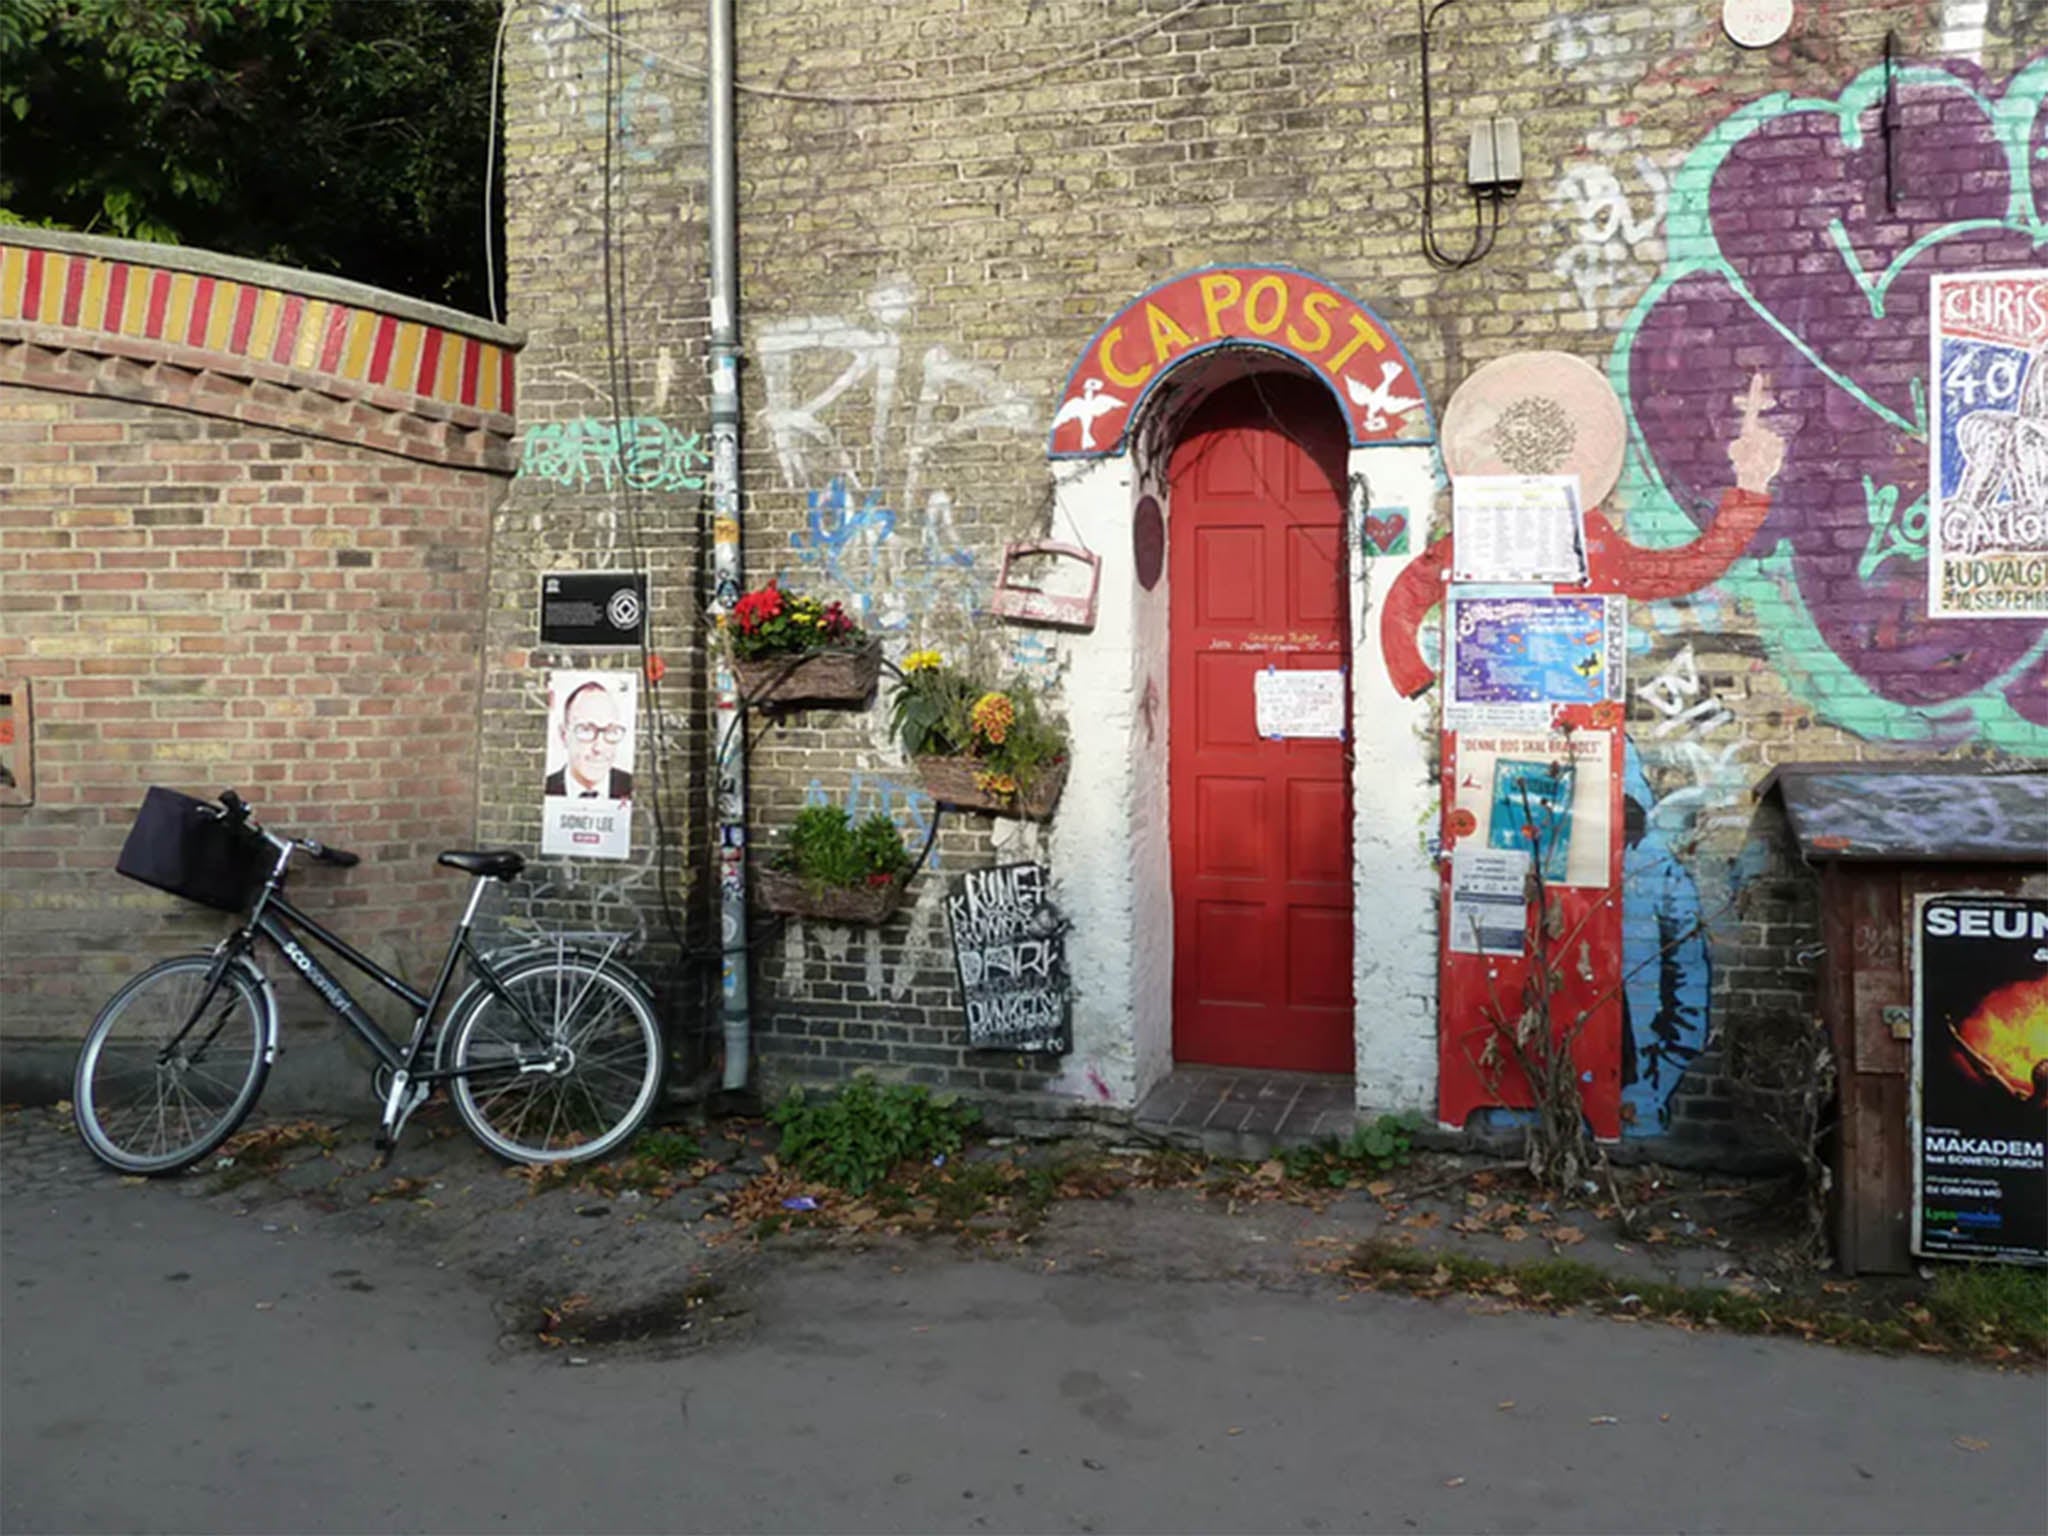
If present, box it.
[483,0,2048,1146]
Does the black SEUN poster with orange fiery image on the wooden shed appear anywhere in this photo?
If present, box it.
[1913,895,2048,1264]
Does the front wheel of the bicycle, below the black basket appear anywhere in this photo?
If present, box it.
[72,954,270,1174]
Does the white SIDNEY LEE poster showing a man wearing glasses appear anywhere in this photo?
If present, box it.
[541,672,639,858]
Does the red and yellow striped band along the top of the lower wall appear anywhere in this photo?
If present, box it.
[0,242,512,416]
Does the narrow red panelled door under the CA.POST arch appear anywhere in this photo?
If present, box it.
[1167,375,1352,1073]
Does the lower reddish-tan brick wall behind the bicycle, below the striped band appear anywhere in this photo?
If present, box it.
[0,228,520,1092]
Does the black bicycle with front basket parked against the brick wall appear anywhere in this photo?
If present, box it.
[72,786,668,1176]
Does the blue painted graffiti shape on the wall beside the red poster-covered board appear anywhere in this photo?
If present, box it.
[1622,741,1714,1137]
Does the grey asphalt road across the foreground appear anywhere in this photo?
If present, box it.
[0,1146,2048,1534]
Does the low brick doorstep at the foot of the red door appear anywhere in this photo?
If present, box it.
[1133,1067,1358,1161]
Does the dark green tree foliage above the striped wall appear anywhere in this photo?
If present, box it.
[0,0,500,311]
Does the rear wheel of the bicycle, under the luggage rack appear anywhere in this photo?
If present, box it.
[449,958,666,1163]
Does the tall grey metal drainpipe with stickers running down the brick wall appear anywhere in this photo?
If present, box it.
[707,0,752,1090]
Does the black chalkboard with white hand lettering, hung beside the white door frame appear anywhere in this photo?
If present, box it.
[946,864,1073,1055]
